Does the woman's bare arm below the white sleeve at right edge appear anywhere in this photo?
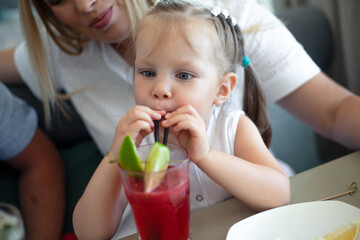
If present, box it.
[279,73,360,149]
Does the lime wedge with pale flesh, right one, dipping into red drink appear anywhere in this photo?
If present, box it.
[145,142,170,192]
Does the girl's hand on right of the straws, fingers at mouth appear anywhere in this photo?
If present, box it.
[162,105,210,163]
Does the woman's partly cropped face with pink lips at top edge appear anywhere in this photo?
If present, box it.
[41,0,130,43]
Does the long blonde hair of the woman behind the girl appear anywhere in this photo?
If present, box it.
[18,0,153,127]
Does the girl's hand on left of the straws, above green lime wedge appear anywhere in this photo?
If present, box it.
[110,105,165,156]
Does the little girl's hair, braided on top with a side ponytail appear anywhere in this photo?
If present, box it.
[139,0,271,146]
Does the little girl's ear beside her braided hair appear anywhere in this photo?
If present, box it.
[213,72,237,105]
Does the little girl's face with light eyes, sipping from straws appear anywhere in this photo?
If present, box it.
[134,18,219,122]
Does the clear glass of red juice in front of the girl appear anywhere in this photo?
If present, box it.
[120,144,191,240]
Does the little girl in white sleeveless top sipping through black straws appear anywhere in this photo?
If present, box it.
[73,0,290,239]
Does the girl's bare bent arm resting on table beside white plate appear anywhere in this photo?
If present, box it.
[197,117,290,210]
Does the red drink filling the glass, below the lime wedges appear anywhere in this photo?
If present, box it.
[126,170,190,240]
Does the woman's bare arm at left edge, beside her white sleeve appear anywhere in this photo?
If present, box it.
[0,47,23,83]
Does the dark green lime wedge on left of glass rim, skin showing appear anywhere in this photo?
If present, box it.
[119,135,144,172]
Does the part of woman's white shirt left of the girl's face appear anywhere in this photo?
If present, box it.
[15,38,135,154]
